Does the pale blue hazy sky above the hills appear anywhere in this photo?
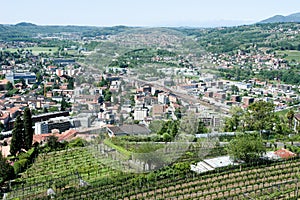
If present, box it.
[0,0,300,26]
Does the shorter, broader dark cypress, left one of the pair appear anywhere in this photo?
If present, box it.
[10,116,24,155]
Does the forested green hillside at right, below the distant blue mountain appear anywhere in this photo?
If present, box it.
[174,23,300,53]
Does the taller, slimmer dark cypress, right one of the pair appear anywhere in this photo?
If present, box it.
[23,107,33,150]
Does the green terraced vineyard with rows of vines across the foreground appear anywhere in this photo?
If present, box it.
[2,145,300,200]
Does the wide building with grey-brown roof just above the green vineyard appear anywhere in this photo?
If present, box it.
[107,124,151,137]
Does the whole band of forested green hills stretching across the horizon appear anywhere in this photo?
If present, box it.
[0,23,300,53]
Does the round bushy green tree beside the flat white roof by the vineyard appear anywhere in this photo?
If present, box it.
[227,133,266,163]
